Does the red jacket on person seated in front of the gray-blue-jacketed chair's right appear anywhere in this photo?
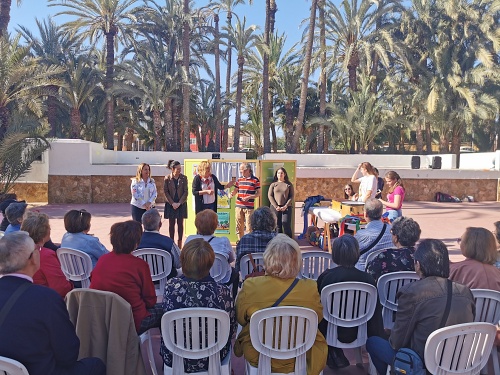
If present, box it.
[90,251,156,330]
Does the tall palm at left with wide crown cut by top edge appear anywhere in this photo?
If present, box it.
[49,0,137,150]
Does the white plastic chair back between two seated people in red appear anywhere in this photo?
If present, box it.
[56,247,93,288]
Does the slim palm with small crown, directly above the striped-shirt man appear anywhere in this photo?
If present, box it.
[228,17,257,152]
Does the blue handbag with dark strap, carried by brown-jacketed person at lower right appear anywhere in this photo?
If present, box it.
[391,280,453,375]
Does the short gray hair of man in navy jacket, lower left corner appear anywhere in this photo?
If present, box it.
[0,231,35,275]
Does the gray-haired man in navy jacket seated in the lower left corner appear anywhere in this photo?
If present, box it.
[0,231,106,375]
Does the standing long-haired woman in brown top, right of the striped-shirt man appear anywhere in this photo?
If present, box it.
[267,168,293,238]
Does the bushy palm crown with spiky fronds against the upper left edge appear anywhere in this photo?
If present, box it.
[0,34,61,140]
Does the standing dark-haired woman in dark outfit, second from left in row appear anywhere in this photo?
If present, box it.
[163,160,187,248]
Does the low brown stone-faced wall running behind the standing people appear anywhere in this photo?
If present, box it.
[13,175,500,204]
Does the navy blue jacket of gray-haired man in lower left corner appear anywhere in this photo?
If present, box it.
[0,276,80,375]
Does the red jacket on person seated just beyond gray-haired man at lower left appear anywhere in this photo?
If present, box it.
[33,247,73,298]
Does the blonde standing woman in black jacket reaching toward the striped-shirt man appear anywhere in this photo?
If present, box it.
[192,161,234,213]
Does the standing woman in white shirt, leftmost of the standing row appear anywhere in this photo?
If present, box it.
[130,163,158,223]
